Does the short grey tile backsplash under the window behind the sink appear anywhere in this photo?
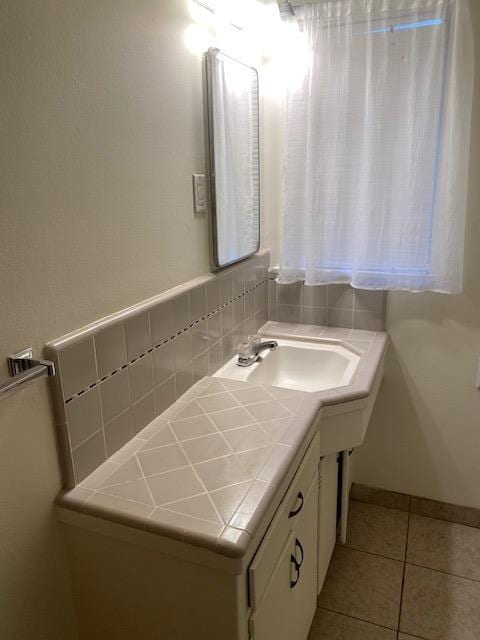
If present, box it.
[268,270,386,331]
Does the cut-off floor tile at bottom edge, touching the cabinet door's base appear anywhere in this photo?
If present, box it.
[308,608,397,640]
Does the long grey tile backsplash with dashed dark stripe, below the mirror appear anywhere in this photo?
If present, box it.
[47,251,269,488]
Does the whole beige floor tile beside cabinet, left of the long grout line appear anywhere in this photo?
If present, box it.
[318,547,403,629]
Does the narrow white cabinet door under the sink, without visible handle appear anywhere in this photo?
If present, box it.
[317,453,338,593]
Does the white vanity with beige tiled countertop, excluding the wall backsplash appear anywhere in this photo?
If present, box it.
[57,322,387,640]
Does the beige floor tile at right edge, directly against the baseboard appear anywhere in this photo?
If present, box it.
[407,514,480,580]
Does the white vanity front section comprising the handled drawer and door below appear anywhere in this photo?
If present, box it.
[249,436,319,640]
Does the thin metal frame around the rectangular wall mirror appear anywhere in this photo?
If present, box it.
[205,47,262,269]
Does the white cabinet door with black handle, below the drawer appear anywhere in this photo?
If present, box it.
[250,473,318,640]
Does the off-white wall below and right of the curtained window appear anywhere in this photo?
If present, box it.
[355,2,480,508]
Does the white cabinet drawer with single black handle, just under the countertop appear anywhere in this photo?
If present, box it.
[248,434,320,608]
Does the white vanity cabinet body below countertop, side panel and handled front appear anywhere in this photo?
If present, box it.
[58,433,335,640]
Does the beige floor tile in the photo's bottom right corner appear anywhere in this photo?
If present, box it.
[400,564,480,640]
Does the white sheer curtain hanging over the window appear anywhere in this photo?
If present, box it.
[278,0,473,292]
